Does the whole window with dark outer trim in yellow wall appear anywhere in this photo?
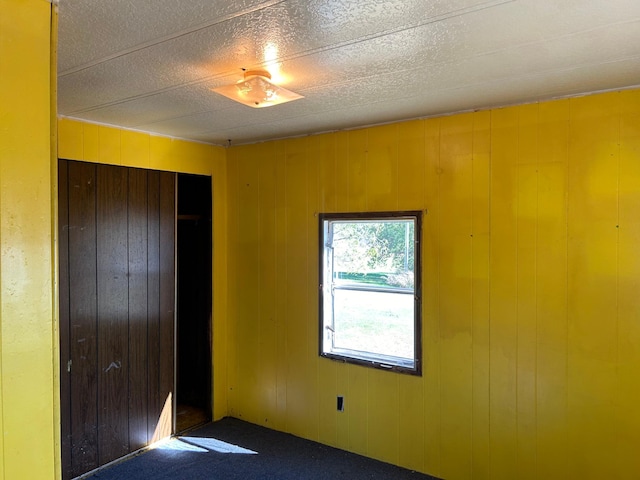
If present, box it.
[319,211,422,375]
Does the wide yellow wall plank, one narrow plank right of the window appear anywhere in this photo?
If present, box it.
[437,114,473,479]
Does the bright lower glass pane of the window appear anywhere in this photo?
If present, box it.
[334,290,414,359]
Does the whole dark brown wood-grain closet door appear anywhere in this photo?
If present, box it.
[59,160,175,478]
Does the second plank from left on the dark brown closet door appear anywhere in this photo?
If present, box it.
[68,162,98,476]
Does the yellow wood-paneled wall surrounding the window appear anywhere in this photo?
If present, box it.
[225,90,640,480]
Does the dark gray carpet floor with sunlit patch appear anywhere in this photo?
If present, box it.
[87,418,437,480]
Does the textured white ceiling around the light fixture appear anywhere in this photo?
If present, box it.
[58,0,640,145]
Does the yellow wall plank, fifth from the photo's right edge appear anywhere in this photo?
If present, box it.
[489,107,519,480]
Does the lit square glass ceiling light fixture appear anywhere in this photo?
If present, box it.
[212,70,304,108]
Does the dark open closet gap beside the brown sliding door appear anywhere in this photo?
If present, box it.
[175,173,213,433]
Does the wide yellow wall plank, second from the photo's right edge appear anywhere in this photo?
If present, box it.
[567,94,620,478]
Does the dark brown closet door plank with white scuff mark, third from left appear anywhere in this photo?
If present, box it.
[97,165,130,464]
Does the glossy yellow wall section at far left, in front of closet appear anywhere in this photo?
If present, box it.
[0,0,59,480]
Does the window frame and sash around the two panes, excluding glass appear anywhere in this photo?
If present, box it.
[318,211,422,375]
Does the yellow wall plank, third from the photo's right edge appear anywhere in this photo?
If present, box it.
[536,100,569,480]
